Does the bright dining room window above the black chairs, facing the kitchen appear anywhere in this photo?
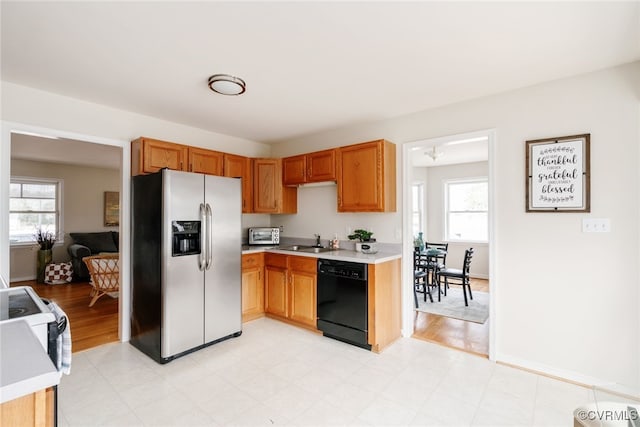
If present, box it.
[445,178,489,242]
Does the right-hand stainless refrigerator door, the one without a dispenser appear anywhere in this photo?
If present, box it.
[204,175,242,343]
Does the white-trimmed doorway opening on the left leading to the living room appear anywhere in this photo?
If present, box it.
[0,123,130,352]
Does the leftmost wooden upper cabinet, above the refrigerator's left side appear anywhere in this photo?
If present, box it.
[131,137,189,175]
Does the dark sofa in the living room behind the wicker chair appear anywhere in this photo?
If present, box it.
[67,231,120,282]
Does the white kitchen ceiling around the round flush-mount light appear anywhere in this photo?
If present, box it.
[1,1,640,149]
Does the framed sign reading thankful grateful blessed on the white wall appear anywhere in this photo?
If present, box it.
[526,133,591,212]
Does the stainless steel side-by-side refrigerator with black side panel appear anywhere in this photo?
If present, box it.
[131,169,242,363]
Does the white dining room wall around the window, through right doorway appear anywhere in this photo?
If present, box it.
[423,162,489,279]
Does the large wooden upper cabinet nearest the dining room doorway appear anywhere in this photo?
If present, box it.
[337,140,396,212]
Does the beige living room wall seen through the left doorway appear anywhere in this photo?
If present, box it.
[10,159,120,282]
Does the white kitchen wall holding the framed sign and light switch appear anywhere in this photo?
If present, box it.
[273,62,640,389]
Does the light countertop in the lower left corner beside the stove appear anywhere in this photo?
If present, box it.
[0,320,60,403]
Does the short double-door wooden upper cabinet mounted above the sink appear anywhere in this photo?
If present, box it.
[282,149,336,185]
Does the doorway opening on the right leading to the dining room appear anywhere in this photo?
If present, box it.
[403,130,495,358]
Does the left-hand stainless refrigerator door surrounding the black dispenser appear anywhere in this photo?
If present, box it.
[161,170,204,358]
